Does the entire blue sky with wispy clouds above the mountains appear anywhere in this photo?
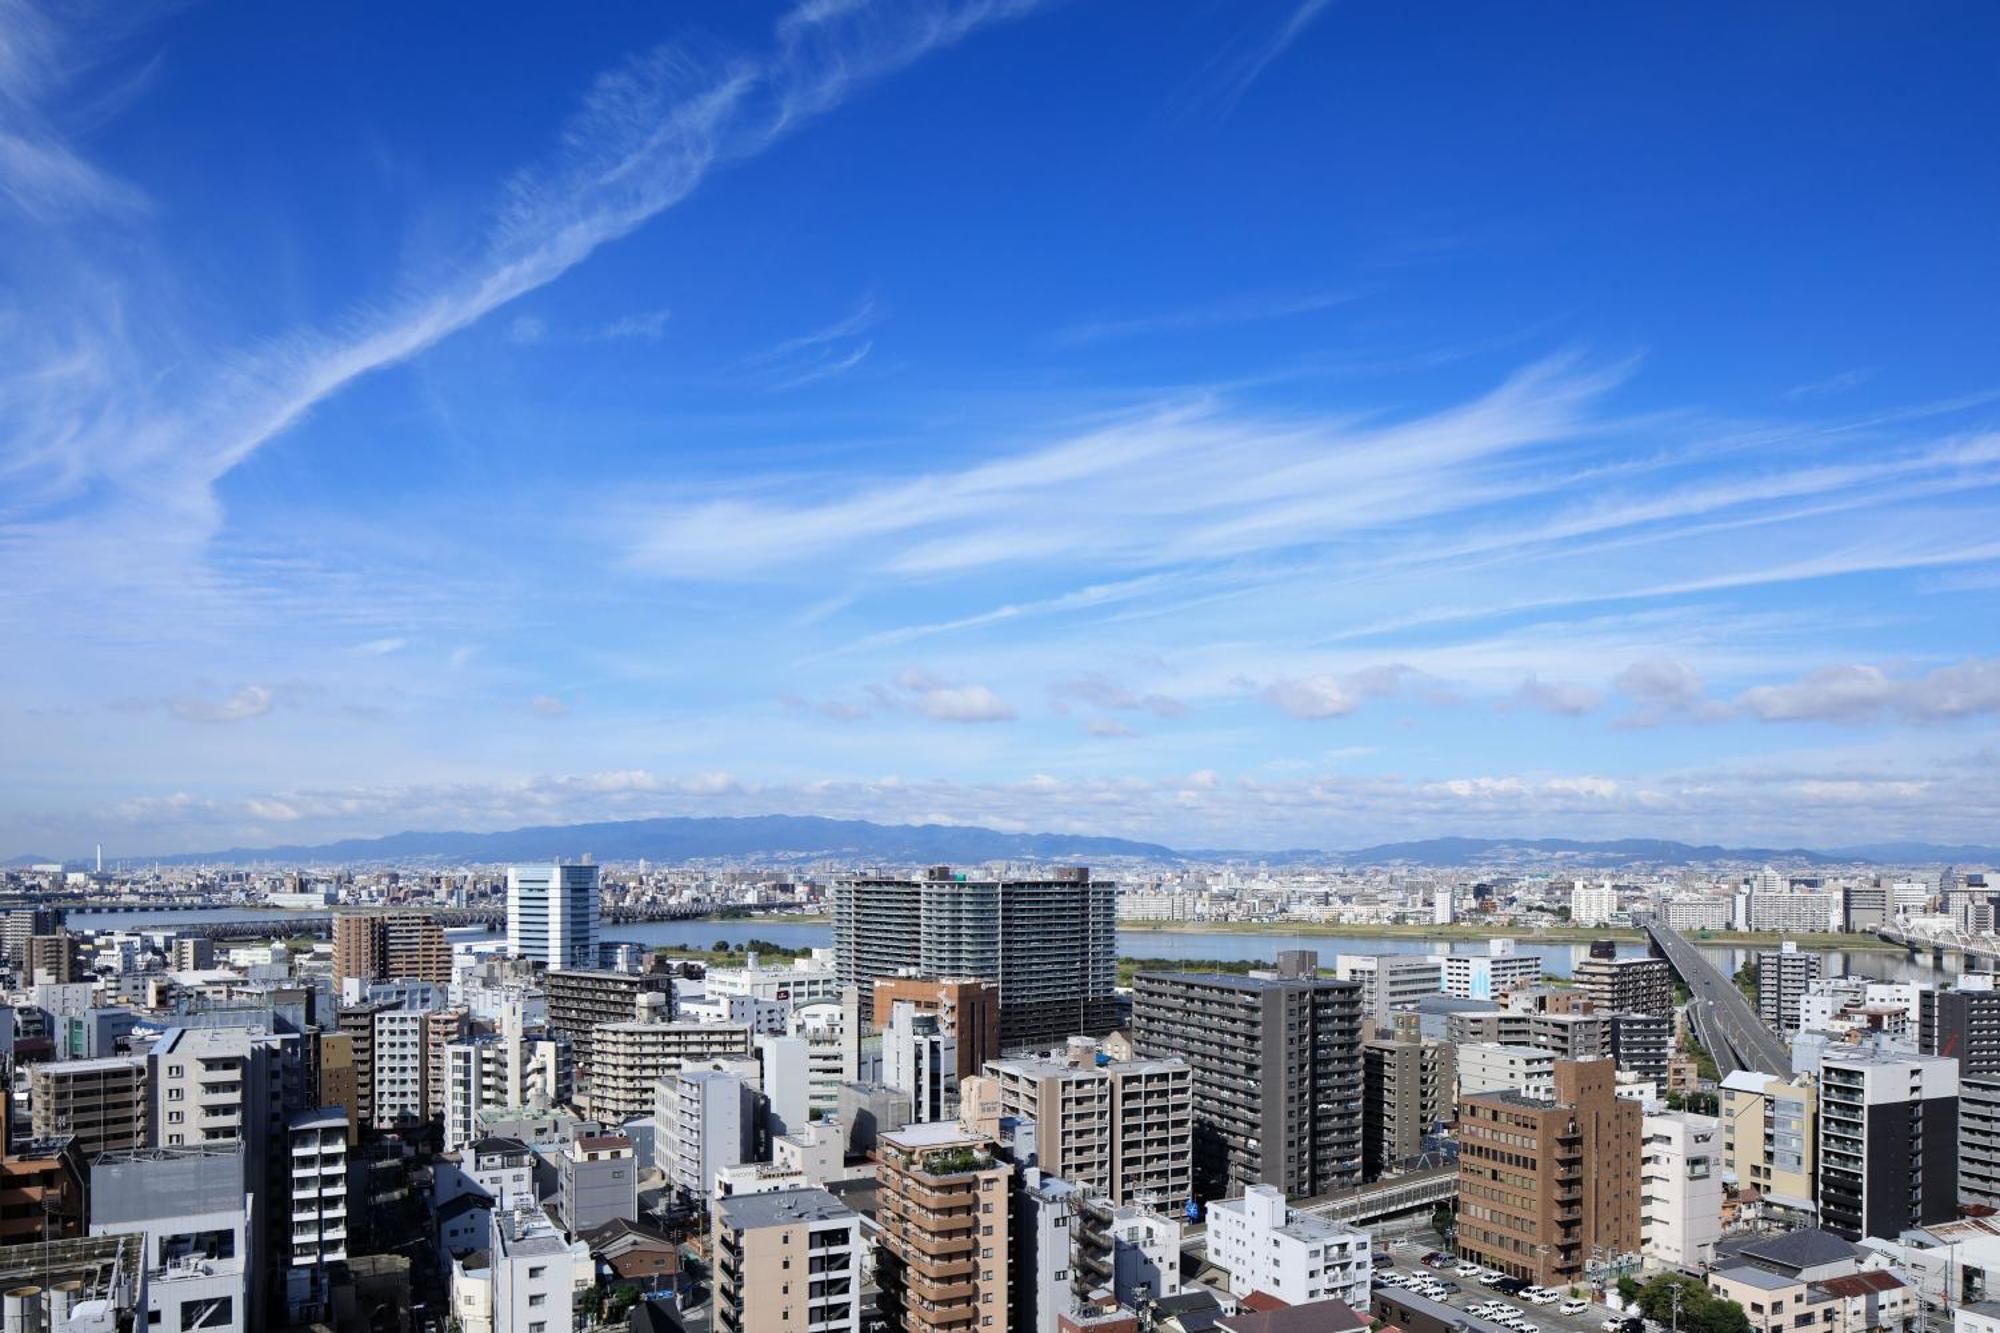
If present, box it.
[0,0,2000,855]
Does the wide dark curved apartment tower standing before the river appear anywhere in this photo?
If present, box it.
[834,865,1118,1051]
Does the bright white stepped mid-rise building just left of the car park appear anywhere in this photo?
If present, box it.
[1208,1185,1374,1309]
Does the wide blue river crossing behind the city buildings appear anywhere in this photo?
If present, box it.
[70,907,1958,981]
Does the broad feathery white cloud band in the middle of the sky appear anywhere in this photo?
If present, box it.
[622,360,1622,580]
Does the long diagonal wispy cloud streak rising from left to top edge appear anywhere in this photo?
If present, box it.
[0,0,1034,584]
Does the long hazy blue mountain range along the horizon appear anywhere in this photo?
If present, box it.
[6,815,2000,867]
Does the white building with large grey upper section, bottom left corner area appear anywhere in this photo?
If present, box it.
[91,1139,254,1333]
